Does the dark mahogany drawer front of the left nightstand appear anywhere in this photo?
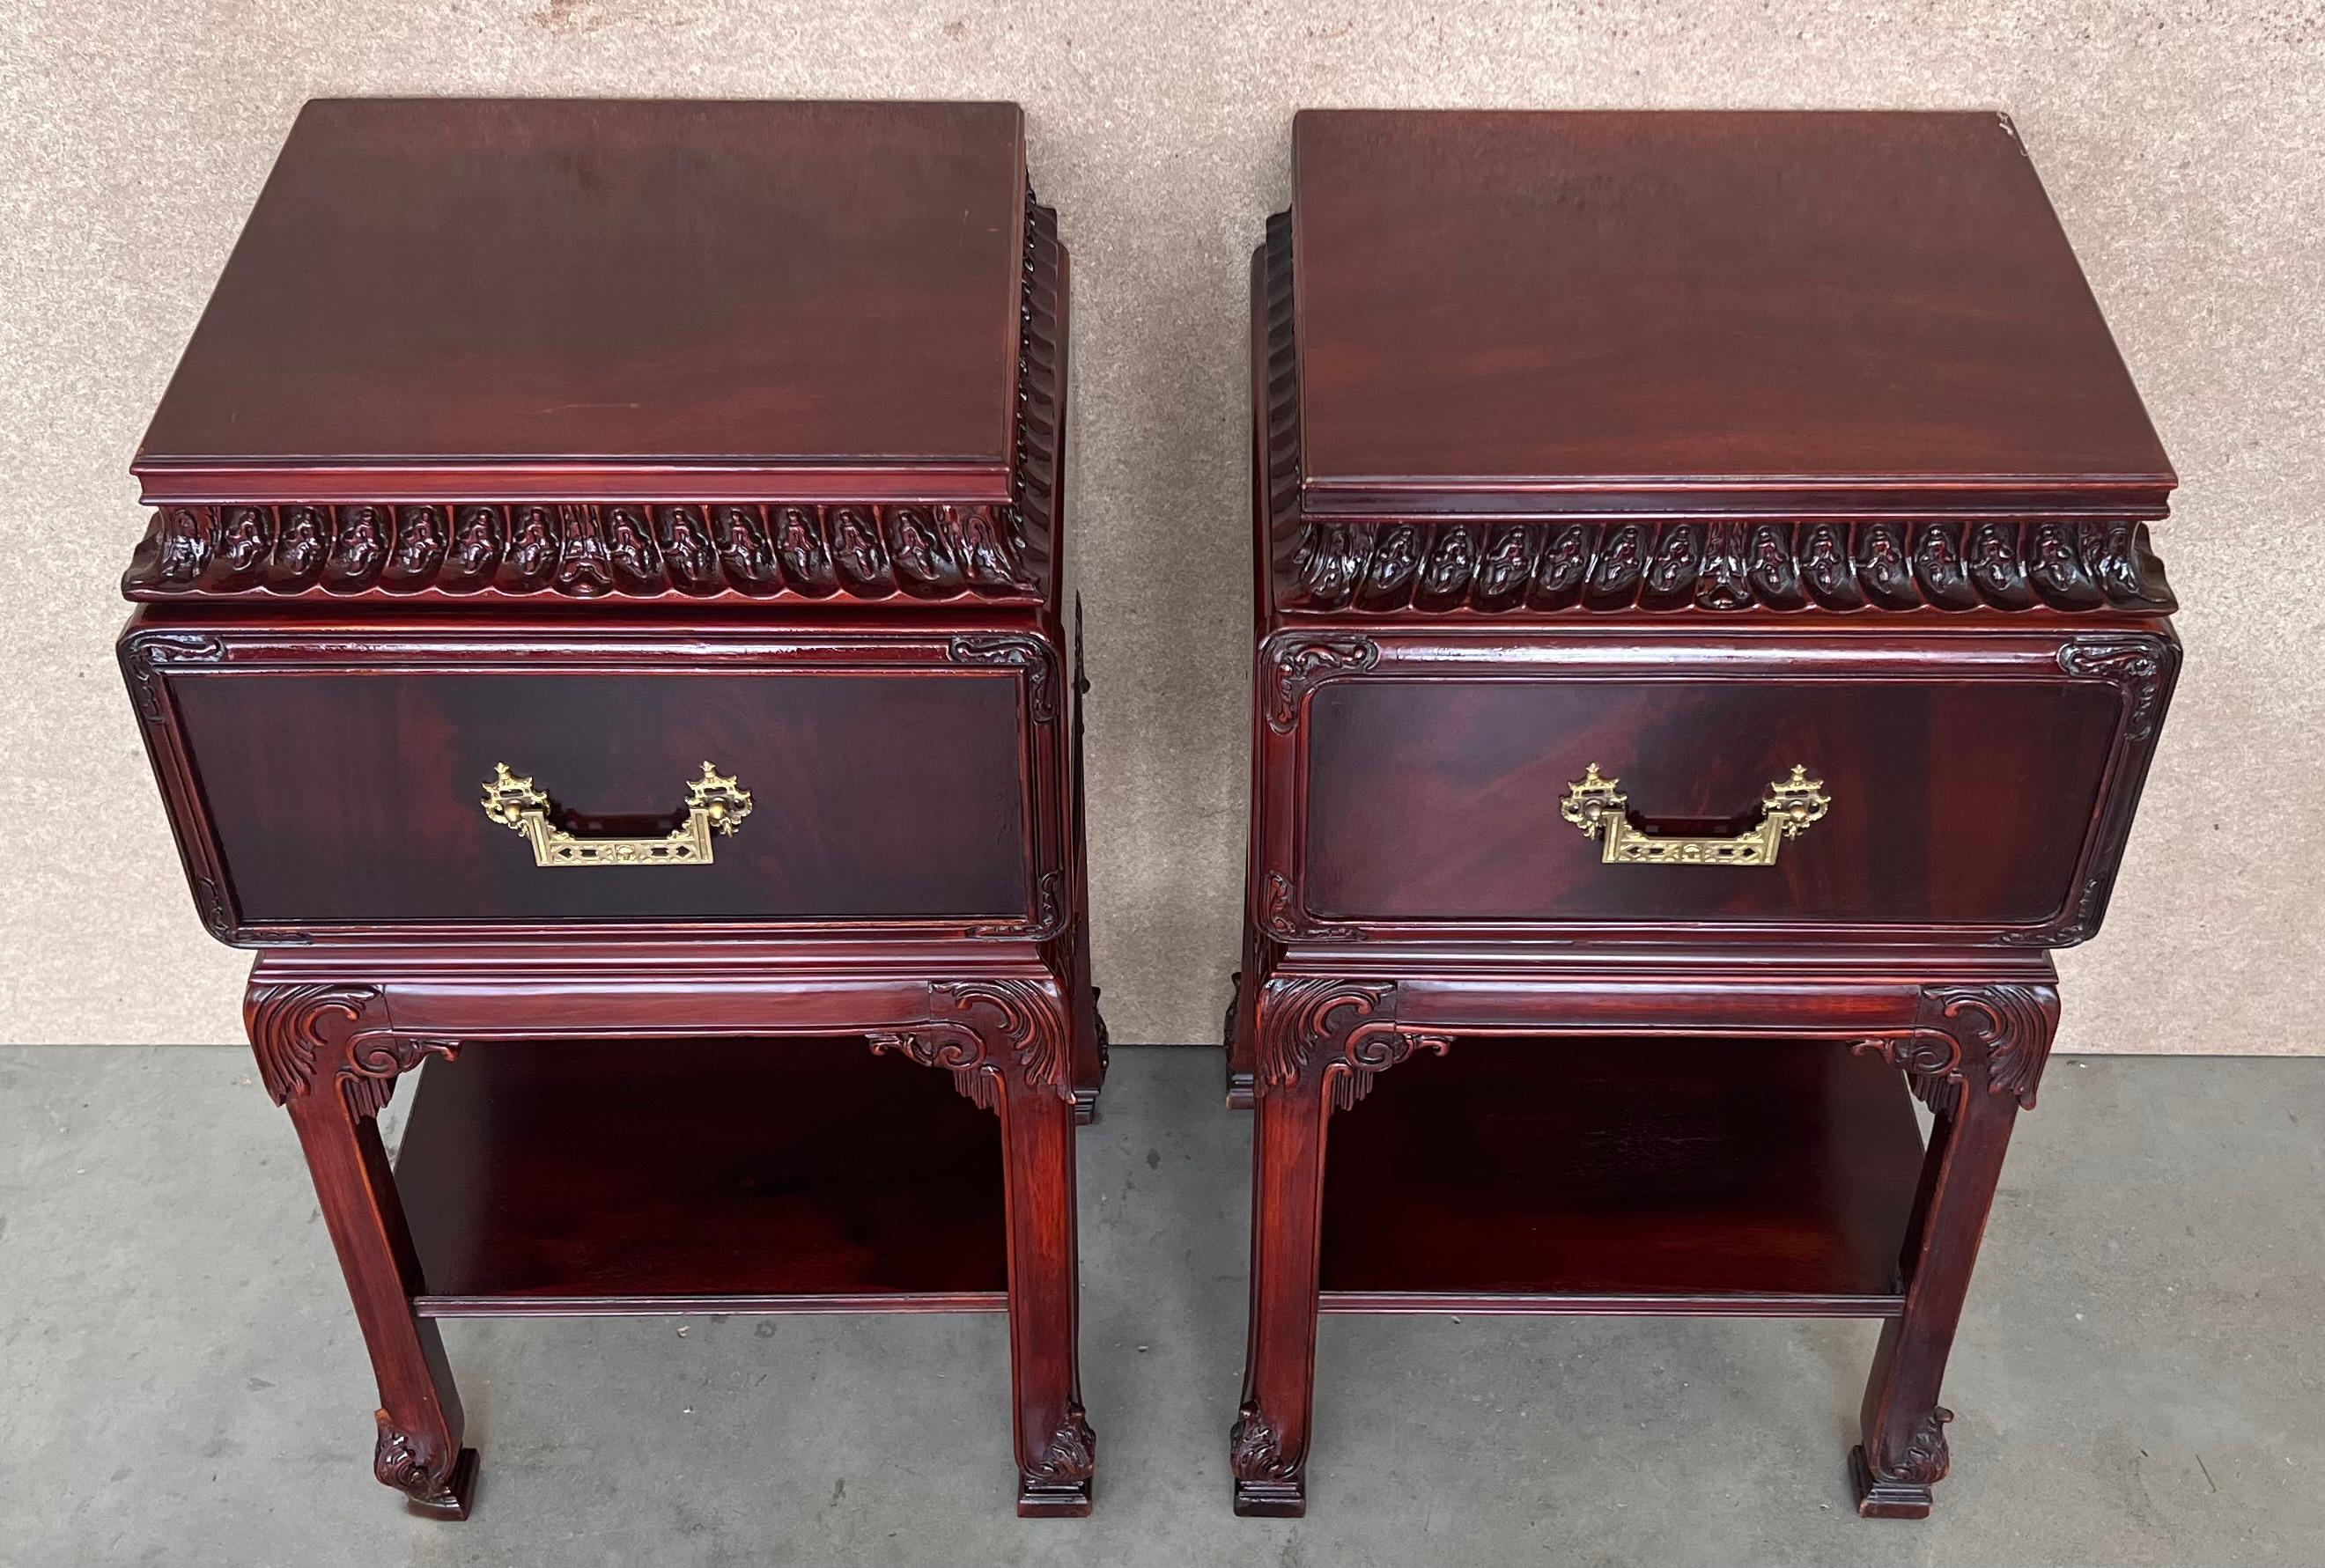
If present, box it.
[150,662,1032,941]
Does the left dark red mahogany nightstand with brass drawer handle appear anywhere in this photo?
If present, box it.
[121,99,1104,1517]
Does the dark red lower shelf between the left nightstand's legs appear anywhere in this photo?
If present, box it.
[395,1038,1009,1317]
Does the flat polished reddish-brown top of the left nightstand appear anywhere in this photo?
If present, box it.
[137,99,1025,499]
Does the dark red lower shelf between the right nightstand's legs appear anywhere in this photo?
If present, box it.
[1321,1038,1923,1317]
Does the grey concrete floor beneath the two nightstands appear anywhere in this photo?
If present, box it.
[0,1048,2325,1568]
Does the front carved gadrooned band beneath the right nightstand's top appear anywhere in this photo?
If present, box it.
[1286,518,2179,615]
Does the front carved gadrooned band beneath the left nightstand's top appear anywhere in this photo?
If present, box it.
[121,502,1049,600]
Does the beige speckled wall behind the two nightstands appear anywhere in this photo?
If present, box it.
[0,0,2325,1052]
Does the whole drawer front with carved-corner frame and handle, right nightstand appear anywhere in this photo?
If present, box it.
[1272,637,2176,943]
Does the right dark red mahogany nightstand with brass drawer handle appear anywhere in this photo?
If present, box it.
[1228,112,2179,1517]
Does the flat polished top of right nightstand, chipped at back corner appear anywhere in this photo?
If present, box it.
[1293,109,2172,506]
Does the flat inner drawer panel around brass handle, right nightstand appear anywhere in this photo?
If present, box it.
[1304,672,2121,927]
